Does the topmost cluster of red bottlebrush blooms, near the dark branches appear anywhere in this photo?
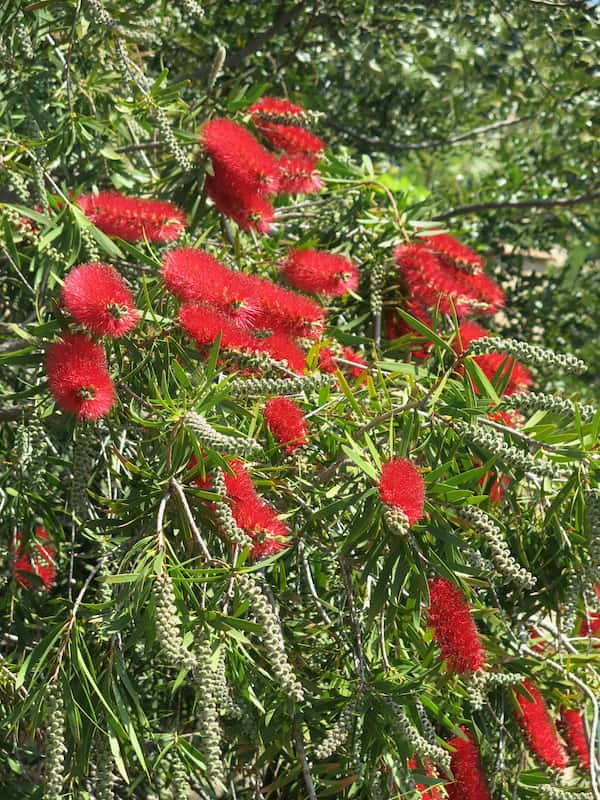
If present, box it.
[200,97,324,233]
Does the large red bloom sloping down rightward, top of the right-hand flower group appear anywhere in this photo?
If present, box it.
[394,244,504,315]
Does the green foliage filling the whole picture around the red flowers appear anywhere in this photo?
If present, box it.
[0,0,600,800]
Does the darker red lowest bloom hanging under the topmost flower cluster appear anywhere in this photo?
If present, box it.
[206,169,275,233]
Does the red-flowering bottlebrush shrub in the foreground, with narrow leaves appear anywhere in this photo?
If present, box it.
[0,83,598,800]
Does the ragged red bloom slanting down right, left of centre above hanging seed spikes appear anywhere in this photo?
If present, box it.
[188,456,290,560]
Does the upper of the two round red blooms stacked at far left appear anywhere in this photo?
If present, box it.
[61,264,140,338]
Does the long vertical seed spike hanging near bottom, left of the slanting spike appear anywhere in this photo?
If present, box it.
[192,635,223,781]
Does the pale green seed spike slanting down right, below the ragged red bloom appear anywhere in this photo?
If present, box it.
[237,575,304,703]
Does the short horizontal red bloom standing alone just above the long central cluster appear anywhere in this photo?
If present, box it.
[280,250,359,297]
